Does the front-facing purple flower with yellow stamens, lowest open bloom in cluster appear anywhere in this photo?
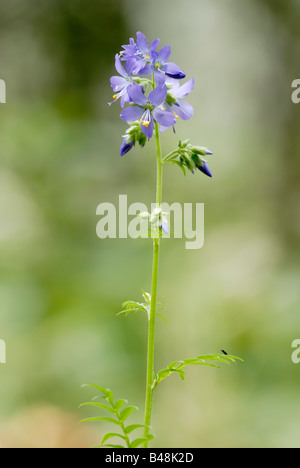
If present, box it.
[121,83,176,140]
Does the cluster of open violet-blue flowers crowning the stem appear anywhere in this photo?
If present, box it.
[110,32,211,176]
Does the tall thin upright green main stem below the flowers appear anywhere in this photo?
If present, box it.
[143,119,162,448]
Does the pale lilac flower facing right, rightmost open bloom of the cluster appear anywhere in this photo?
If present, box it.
[160,78,195,132]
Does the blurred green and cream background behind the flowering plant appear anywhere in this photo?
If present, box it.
[0,0,300,448]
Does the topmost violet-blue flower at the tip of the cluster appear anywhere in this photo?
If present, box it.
[121,32,160,75]
